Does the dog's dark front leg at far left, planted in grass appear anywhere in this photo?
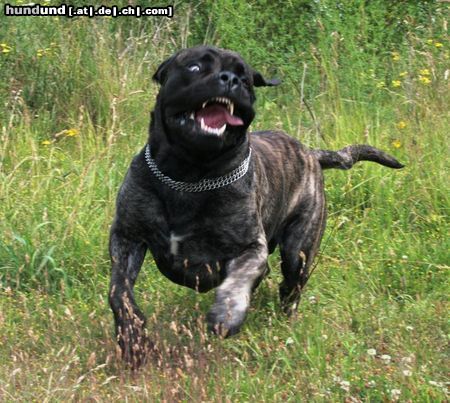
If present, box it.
[109,230,147,368]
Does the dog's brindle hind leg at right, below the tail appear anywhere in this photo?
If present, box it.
[280,178,326,315]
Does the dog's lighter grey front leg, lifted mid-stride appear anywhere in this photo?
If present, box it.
[207,235,268,337]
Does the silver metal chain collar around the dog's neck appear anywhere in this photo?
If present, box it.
[145,144,252,193]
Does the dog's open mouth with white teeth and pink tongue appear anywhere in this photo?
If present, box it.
[189,97,244,136]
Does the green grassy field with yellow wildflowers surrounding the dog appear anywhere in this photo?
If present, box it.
[0,0,450,402]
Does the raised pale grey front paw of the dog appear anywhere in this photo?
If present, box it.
[206,304,245,338]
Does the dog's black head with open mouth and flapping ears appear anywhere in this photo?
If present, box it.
[153,46,280,153]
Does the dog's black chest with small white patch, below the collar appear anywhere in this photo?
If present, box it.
[141,194,257,291]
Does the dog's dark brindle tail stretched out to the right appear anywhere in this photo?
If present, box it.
[312,144,404,169]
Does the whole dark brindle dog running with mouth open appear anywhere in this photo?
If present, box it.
[109,46,402,366]
